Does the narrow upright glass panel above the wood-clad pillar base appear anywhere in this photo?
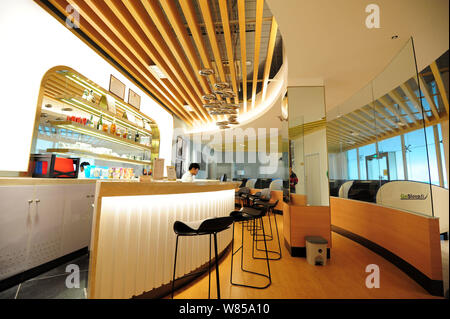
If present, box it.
[287,86,329,206]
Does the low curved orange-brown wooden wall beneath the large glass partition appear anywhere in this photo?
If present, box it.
[330,197,443,296]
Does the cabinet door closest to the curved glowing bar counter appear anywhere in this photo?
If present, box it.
[62,184,95,255]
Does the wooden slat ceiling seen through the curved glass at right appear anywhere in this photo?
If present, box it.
[327,61,449,152]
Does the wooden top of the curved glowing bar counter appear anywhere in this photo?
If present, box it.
[97,180,240,197]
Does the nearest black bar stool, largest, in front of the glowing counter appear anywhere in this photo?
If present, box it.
[172,216,233,299]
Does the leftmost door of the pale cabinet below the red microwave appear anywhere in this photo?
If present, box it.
[0,186,34,280]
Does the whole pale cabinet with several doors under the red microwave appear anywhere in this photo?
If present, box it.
[0,184,95,280]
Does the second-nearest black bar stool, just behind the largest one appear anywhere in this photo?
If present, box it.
[230,206,272,289]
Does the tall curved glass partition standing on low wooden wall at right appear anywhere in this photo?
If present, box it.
[327,39,448,222]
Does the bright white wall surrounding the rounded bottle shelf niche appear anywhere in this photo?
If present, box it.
[0,0,173,171]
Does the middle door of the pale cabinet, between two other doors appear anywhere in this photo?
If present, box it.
[28,185,65,268]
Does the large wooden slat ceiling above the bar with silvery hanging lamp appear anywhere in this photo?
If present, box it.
[40,0,280,126]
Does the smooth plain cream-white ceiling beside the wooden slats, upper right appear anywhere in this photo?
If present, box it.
[266,0,449,110]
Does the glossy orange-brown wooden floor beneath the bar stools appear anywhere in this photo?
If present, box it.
[171,215,444,299]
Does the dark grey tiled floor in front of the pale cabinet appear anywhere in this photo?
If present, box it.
[0,255,89,299]
